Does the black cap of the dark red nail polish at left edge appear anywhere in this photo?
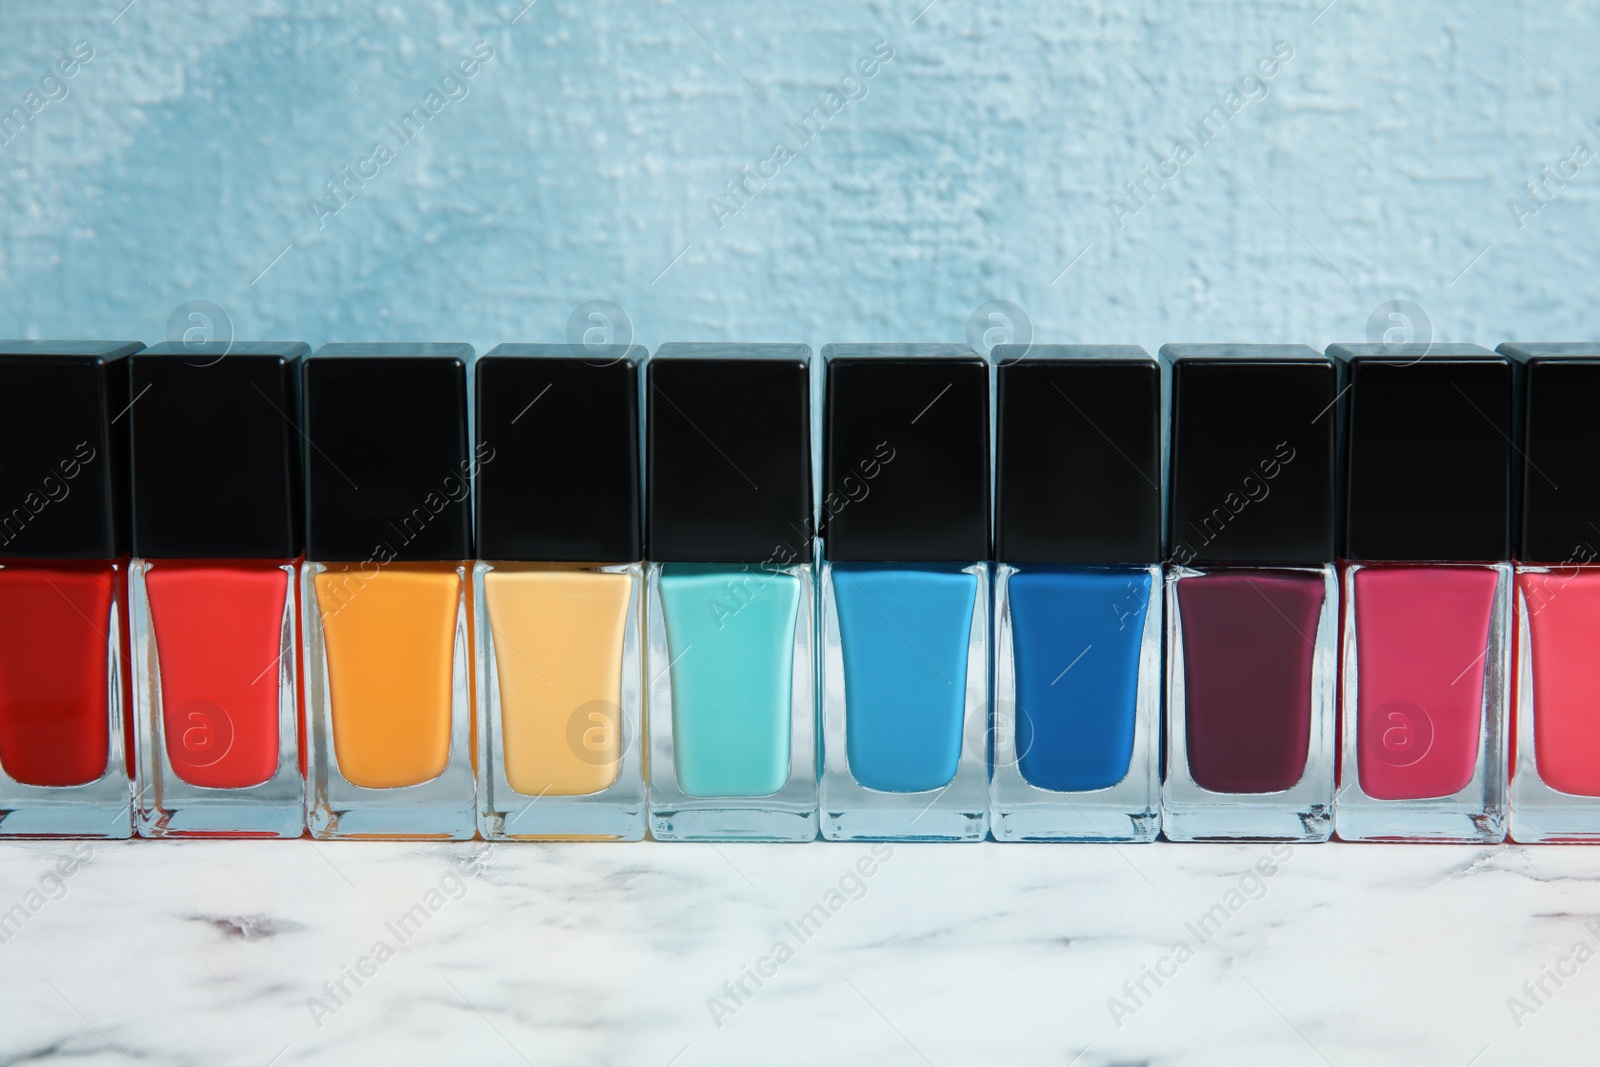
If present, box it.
[0,341,144,560]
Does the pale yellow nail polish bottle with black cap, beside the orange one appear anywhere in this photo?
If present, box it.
[472,344,645,841]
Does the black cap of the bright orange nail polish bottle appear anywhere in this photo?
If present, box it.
[301,344,480,563]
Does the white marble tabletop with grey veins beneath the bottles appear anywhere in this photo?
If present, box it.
[0,841,1600,1067]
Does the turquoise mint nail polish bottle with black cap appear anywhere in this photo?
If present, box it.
[645,344,816,841]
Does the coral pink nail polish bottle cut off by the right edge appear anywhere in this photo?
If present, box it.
[1499,342,1600,845]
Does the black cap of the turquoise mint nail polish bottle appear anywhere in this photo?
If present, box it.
[645,344,814,565]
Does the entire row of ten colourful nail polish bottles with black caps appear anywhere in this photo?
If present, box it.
[0,344,1600,840]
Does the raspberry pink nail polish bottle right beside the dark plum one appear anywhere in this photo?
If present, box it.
[1328,344,1520,843]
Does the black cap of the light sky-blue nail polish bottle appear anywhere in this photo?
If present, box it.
[822,344,989,563]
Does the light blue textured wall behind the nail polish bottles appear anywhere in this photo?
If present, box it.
[0,0,1600,356]
